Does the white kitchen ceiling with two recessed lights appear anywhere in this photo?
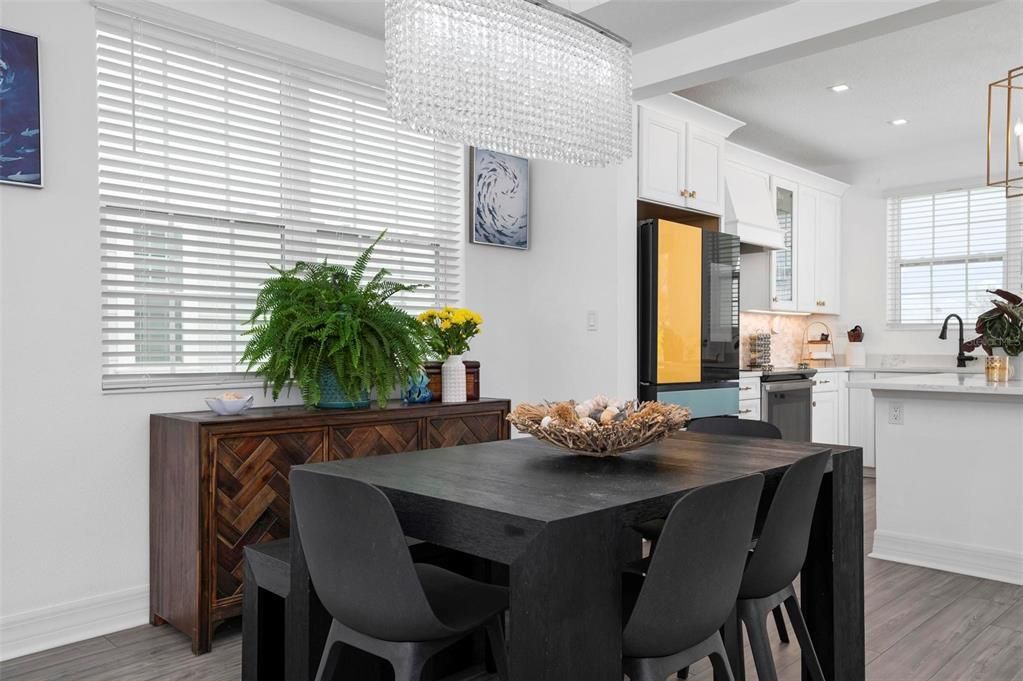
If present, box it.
[679,0,1023,174]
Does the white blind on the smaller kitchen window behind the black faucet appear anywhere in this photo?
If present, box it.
[888,187,1020,326]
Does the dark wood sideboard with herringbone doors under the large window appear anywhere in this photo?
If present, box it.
[149,399,510,654]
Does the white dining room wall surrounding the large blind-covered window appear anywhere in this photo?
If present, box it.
[0,0,635,659]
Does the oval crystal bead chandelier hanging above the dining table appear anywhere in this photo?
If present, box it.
[385,0,632,166]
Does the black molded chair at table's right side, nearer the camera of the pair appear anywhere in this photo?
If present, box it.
[622,474,764,681]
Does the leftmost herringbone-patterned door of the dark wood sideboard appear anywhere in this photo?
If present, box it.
[213,428,324,600]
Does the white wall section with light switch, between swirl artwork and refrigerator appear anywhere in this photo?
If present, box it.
[466,161,618,402]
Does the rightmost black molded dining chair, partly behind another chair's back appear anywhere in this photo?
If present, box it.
[737,451,831,681]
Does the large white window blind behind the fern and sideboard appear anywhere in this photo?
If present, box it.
[97,9,463,390]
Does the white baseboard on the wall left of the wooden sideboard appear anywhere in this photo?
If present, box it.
[0,586,149,660]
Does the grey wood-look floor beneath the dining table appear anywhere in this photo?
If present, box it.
[7,480,1023,681]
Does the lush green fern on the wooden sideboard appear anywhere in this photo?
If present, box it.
[241,233,427,407]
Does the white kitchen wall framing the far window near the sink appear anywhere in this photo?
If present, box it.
[820,136,986,356]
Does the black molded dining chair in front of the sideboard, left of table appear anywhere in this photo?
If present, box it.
[291,469,508,681]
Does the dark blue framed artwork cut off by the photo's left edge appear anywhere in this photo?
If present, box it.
[0,29,43,187]
